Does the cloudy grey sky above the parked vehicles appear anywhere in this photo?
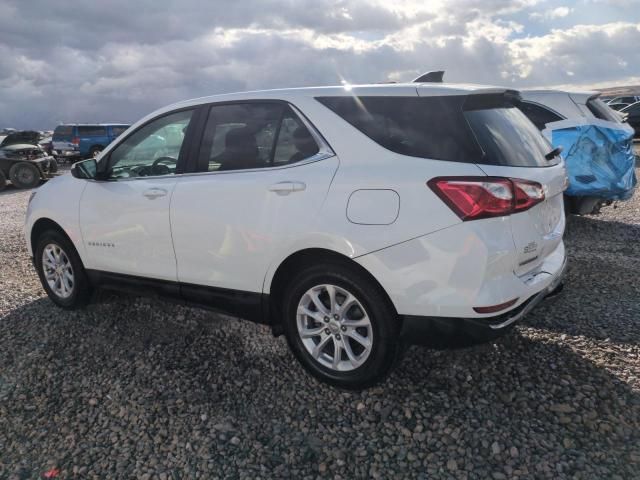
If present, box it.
[0,0,640,129]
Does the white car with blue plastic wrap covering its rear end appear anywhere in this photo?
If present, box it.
[519,90,637,214]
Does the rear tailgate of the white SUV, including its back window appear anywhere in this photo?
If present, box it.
[464,96,566,275]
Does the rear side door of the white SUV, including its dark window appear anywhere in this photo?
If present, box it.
[171,101,338,296]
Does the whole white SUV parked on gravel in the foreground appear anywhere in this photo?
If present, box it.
[25,84,566,388]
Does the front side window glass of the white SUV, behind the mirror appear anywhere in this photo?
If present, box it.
[109,110,193,179]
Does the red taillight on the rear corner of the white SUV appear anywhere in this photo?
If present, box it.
[427,177,544,221]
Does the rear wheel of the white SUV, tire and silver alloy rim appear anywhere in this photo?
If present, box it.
[282,262,402,390]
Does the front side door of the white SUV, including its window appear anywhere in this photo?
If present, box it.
[80,110,193,281]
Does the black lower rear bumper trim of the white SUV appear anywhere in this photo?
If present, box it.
[400,259,567,348]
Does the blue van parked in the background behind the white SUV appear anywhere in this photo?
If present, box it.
[52,123,129,160]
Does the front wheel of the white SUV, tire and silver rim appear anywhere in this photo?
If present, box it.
[34,230,92,310]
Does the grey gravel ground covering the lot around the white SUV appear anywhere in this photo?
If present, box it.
[0,172,640,479]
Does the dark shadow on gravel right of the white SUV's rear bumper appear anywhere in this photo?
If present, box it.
[523,217,640,344]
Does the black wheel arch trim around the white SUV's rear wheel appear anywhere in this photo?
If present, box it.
[265,248,397,335]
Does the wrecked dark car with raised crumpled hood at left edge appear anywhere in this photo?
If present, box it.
[0,131,58,190]
